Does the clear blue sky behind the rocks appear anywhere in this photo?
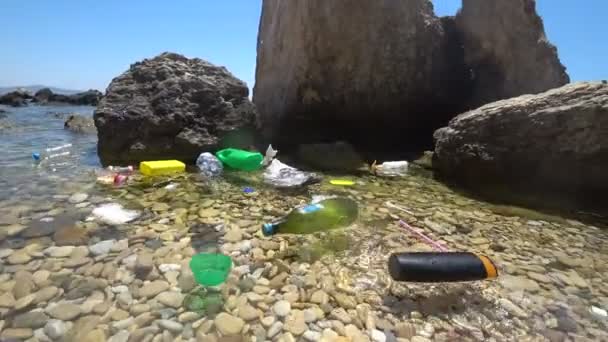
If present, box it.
[0,0,608,90]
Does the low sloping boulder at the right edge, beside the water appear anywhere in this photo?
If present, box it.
[433,82,608,208]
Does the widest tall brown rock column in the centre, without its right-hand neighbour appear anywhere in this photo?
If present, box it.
[254,0,468,152]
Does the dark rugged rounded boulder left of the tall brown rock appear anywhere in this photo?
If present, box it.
[94,53,257,163]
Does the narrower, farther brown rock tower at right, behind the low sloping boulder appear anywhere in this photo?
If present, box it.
[456,0,570,108]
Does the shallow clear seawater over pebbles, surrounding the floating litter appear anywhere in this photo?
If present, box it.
[0,107,608,341]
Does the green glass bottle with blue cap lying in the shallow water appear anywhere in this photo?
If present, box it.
[262,198,359,236]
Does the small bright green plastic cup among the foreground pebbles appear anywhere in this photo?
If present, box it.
[190,253,232,286]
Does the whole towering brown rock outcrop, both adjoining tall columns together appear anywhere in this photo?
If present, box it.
[253,0,567,151]
